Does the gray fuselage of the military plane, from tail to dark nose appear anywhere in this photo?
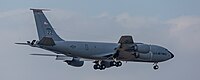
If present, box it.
[39,41,173,62]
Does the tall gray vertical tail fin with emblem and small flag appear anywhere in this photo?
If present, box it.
[30,9,63,41]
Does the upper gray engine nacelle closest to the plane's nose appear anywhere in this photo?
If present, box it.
[135,44,150,53]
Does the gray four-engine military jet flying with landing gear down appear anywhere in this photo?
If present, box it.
[16,9,174,70]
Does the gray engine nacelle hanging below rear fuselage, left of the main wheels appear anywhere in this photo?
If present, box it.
[65,59,84,67]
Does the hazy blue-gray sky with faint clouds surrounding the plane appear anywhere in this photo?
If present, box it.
[0,0,200,80]
